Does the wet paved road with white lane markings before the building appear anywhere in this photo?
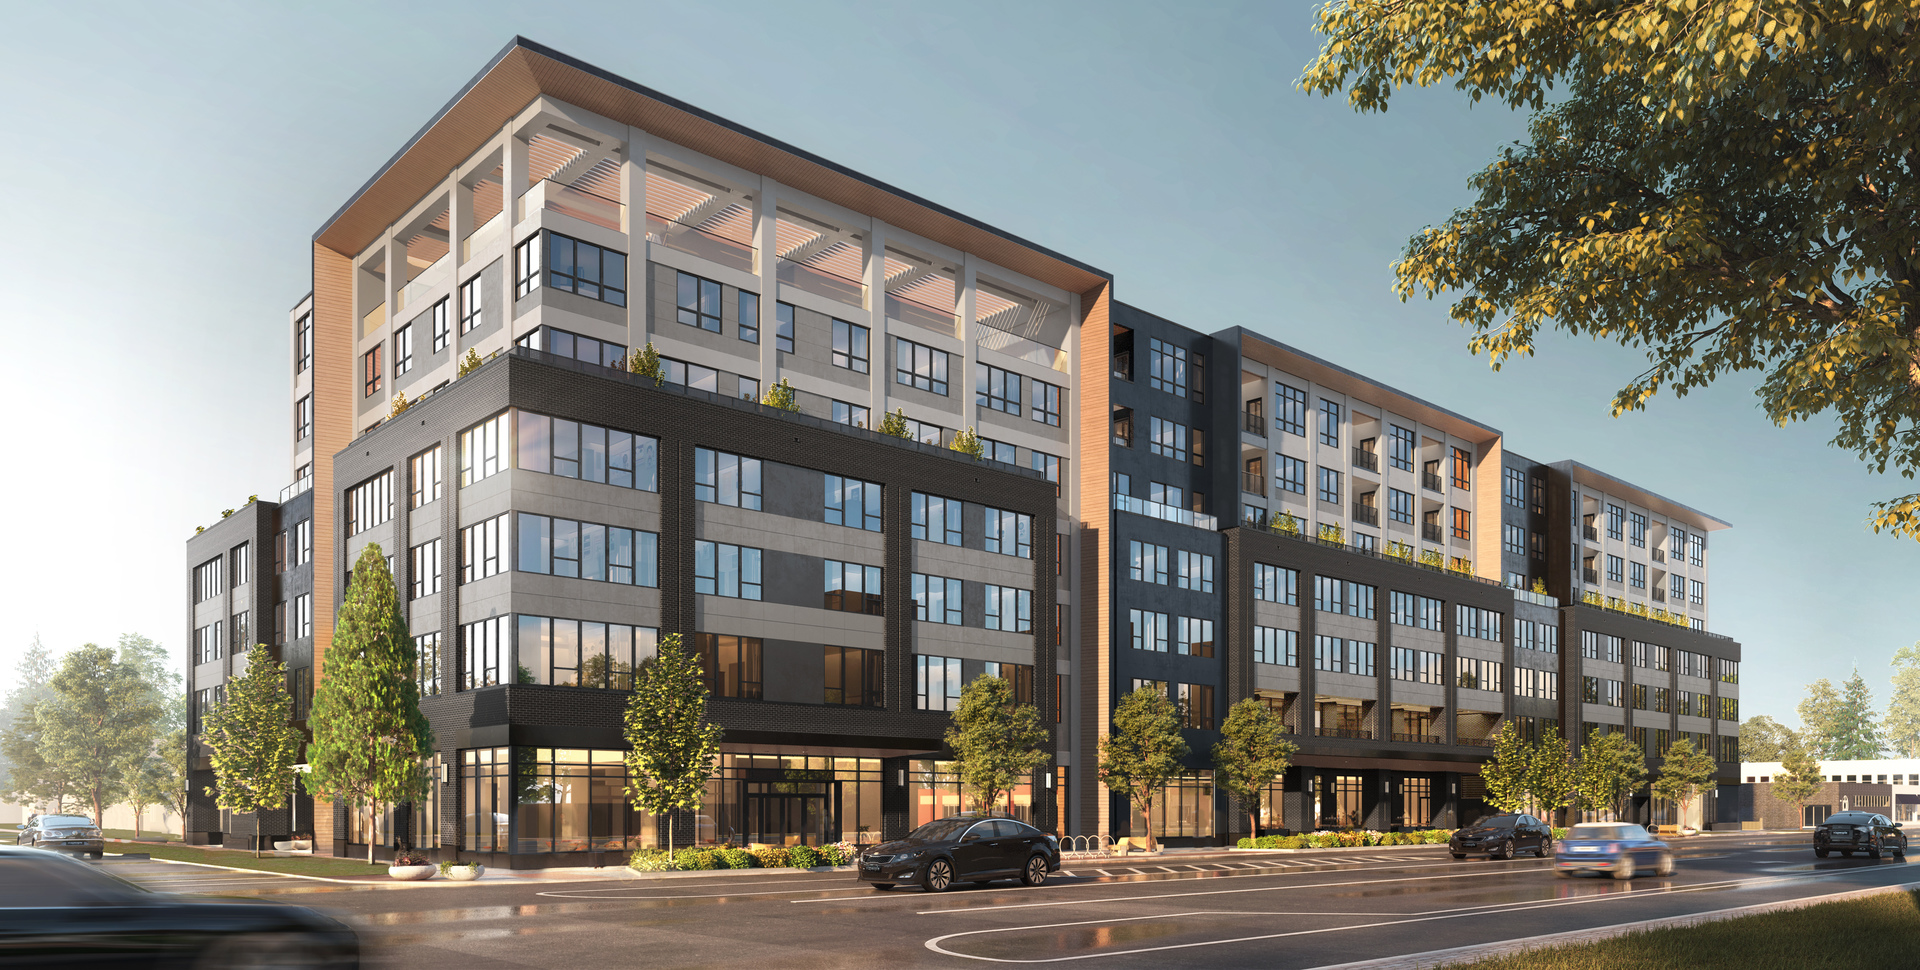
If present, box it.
[115,837,1920,970]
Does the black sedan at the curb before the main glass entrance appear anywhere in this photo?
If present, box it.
[858,814,1060,893]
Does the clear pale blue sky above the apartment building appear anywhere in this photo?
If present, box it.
[0,0,1920,720]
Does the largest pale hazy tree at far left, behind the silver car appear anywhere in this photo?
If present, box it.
[35,643,159,824]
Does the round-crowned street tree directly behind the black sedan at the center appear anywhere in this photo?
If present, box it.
[947,676,1054,812]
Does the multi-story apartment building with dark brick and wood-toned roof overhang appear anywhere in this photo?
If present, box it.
[188,40,1738,864]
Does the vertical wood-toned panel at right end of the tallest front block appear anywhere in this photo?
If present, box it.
[1073,282,1114,832]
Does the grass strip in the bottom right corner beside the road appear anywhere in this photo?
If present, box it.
[1448,893,1920,970]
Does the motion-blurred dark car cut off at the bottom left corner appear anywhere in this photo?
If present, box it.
[0,845,359,970]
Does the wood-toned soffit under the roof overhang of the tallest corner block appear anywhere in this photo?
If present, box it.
[315,40,1102,292]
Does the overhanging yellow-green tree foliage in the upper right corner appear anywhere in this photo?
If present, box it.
[1300,0,1920,538]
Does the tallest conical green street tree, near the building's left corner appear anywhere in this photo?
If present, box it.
[307,542,434,864]
